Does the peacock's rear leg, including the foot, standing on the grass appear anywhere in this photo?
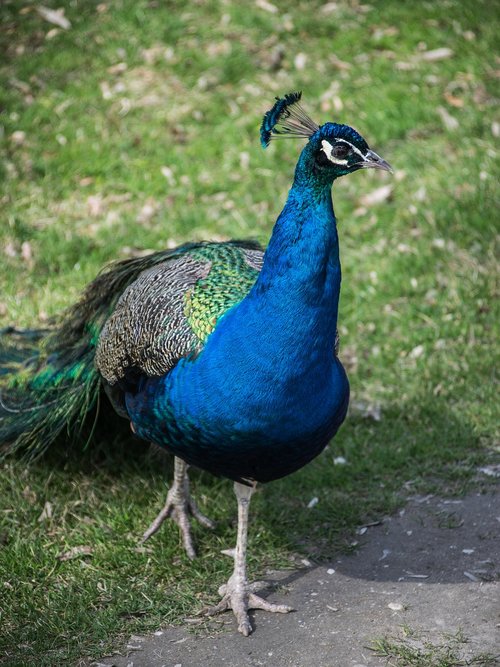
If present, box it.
[141,456,214,558]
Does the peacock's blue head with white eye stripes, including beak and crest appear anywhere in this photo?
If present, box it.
[260,92,392,183]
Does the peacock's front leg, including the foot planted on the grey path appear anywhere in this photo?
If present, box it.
[203,482,293,637]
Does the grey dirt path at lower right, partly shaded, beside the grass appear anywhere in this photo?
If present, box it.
[92,492,500,667]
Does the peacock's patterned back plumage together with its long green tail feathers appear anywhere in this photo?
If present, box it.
[0,241,263,458]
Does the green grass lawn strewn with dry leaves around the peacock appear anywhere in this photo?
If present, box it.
[0,0,500,667]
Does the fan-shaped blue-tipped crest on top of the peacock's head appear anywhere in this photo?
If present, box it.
[260,91,319,148]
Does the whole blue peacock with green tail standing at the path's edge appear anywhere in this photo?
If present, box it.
[0,92,391,636]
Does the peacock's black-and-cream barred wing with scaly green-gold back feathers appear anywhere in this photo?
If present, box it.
[95,243,263,386]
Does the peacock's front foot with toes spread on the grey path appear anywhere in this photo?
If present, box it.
[201,576,294,637]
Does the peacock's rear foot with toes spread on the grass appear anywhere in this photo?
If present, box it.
[141,484,215,560]
